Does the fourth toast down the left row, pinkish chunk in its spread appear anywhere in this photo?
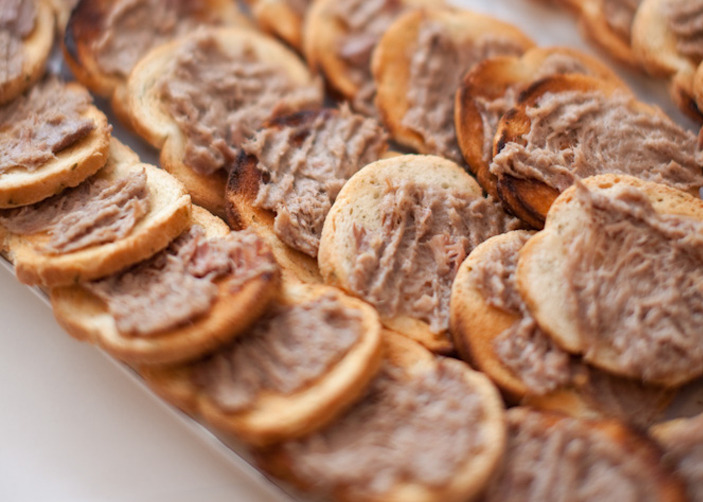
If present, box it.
[49,206,279,365]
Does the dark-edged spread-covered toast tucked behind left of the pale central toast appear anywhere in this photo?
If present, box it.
[226,106,388,282]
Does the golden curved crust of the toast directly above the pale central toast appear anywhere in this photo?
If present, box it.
[371,8,534,153]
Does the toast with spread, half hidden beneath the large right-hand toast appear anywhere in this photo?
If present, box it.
[451,231,674,426]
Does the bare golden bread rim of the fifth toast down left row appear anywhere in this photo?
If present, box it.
[139,283,382,447]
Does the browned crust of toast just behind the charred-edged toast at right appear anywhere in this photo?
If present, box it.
[454,47,625,197]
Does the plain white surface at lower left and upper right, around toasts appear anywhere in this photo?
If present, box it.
[0,0,693,502]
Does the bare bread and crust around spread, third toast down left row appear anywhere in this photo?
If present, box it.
[2,139,191,287]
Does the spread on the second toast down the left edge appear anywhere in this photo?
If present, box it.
[0,78,95,174]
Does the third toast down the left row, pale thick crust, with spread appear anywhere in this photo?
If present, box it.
[0,139,191,287]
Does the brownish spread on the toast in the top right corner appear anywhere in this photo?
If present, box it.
[664,0,703,63]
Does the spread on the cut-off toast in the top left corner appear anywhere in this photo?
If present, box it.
[0,0,37,82]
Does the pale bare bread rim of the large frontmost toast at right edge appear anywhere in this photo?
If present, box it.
[516,174,703,387]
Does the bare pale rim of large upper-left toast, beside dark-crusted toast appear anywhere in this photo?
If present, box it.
[124,28,322,217]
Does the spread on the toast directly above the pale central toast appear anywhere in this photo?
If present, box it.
[402,21,523,164]
